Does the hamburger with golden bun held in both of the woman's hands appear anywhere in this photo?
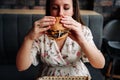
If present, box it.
[47,17,69,39]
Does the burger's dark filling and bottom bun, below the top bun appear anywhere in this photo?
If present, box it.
[47,30,69,39]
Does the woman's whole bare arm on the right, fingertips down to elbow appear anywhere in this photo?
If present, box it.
[61,16,105,68]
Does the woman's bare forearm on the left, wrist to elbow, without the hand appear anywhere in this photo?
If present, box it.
[16,38,33,71]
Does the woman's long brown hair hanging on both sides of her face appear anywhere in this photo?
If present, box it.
[46,0,84,25]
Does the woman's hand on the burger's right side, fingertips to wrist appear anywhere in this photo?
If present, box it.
[61,16,84,42]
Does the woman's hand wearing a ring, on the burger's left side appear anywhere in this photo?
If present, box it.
[26,16,55,40]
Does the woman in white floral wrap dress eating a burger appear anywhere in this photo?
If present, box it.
[16,0,105,77]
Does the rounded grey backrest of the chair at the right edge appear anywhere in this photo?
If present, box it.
[103,20,120,41]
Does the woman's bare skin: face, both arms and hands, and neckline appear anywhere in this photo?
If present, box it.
[16,0,105,71]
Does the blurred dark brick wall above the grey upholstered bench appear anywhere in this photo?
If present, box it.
[0,0,120,24]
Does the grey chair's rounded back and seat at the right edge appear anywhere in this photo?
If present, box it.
[103,20,120,56]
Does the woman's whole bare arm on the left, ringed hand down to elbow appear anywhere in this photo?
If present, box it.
[16,16,55,71]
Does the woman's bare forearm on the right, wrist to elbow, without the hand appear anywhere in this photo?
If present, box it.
[79,40,105,68]
